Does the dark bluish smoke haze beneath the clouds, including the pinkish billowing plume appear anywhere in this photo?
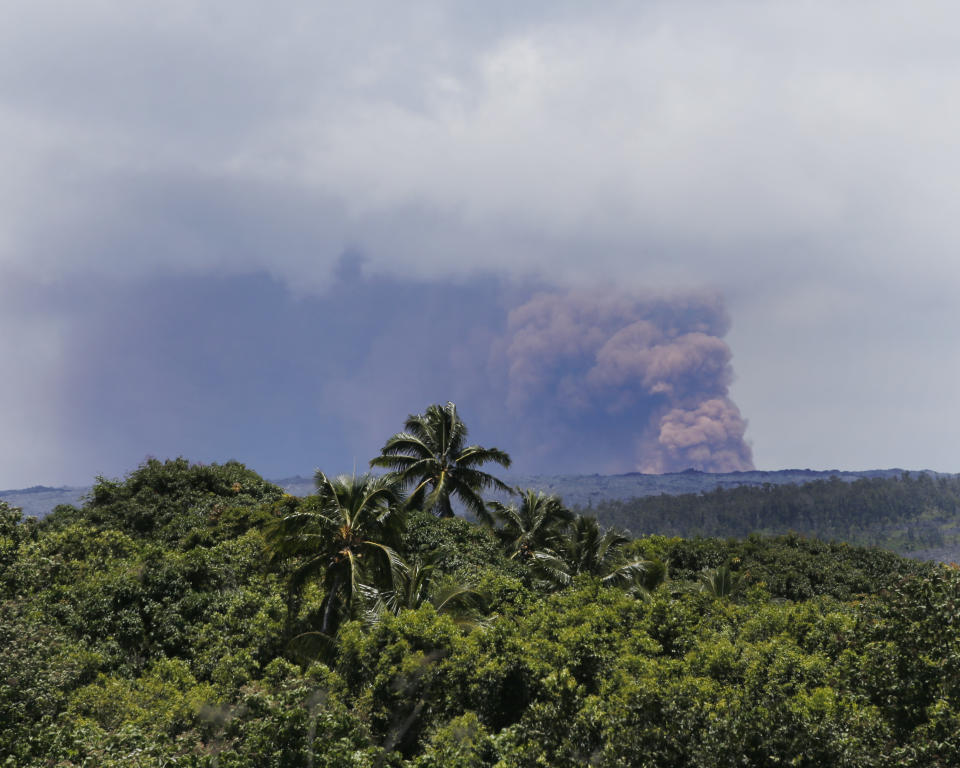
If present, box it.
[13,257,752,483]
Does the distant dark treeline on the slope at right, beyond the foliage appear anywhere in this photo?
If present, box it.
[589,473,960,552]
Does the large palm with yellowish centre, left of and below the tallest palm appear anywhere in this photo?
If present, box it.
[266,470,404,636]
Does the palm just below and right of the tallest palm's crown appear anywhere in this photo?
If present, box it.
[478,488,573,560]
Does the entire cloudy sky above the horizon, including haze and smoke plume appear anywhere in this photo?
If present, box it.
[0,0,960,488]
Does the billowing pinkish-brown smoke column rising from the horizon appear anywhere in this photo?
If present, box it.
[502,292,753,473]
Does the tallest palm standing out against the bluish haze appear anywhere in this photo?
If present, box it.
[370,402,510,517]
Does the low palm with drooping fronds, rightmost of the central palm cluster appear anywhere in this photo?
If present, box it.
[536,515,666,596]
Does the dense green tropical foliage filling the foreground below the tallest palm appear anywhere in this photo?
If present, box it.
[0,404,960,768]
